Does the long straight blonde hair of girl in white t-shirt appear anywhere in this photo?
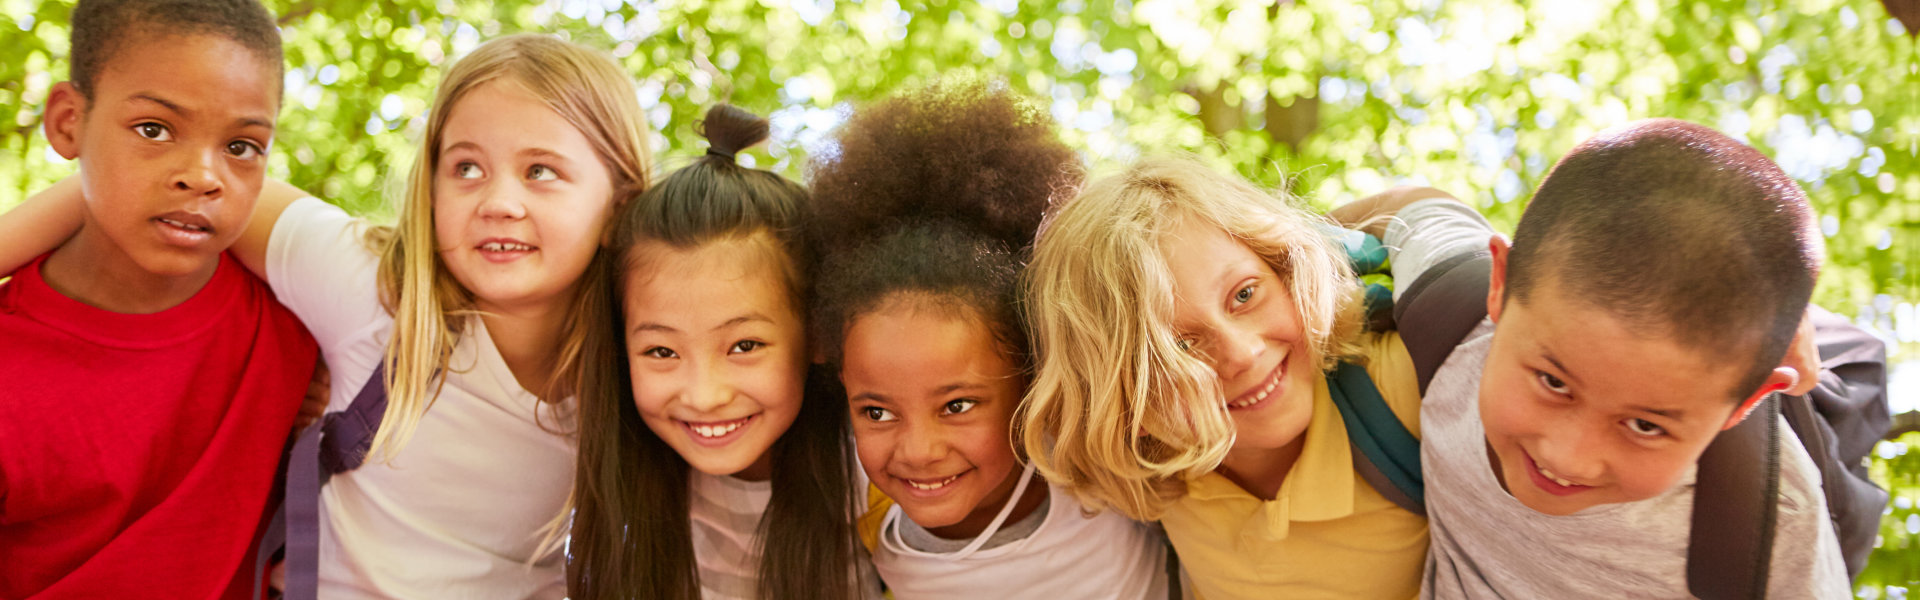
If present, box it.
[367,35,651,462]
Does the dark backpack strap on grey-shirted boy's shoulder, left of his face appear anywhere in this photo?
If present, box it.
[1394,248,1494,394]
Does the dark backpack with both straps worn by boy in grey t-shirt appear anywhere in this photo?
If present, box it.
[1394,250,1893,600]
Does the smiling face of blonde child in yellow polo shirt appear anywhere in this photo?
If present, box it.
[1162,217,1319,463]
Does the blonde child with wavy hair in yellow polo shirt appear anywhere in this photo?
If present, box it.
[1020,160,1427,600]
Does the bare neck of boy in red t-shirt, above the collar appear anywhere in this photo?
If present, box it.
[40,223,221,315]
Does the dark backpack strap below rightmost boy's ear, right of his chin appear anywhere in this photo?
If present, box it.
[1686,394,1780,600]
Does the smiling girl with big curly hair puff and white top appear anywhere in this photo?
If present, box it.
[808,79,1167,600]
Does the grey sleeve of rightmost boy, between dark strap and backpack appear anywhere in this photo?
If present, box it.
[1766,417,1853,598]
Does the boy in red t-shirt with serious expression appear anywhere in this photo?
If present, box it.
[0,0,315,598]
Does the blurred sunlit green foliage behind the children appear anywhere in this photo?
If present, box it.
[0,0,1920,598]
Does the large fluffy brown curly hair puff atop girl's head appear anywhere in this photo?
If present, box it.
[806,75,1085,250]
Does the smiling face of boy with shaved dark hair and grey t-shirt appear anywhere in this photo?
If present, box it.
[1480,246,1791,515]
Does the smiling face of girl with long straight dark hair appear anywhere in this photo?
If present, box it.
[622,231,806,479]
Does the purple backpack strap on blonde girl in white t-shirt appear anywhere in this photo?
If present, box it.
[284,362,386,600]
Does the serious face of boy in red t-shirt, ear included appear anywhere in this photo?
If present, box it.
[48,35,280,277]
